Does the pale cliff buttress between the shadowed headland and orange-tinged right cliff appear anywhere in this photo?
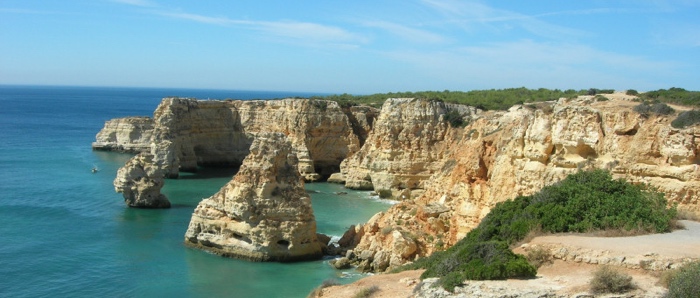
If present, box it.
[341,98,476,199]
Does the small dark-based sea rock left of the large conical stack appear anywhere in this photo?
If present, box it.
[114,153,170,208]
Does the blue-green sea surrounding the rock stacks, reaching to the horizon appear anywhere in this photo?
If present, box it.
[0,86,389,297]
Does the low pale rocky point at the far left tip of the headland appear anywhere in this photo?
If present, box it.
[92,117,154,153]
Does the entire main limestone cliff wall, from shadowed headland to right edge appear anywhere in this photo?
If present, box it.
[97,96,700,271]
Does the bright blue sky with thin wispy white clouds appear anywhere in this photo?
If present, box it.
[0,0,700,94]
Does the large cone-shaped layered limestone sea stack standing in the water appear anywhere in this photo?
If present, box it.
[180,133,322,262]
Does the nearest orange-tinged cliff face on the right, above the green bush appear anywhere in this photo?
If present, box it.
[345,98,700,271]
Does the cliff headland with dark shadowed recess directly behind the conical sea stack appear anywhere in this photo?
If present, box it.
[152,98,365,181]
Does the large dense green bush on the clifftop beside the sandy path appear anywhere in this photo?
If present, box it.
[402,170,676,291]
